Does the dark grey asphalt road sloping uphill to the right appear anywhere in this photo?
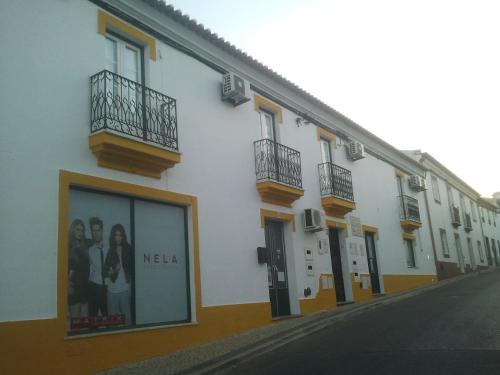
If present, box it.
[217,271,500,375]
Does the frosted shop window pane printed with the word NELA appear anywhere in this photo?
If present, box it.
[134,200,189,324]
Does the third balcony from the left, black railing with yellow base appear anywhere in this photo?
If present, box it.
[318,163,356,218]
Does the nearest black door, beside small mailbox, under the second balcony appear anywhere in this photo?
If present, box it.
[265,220,290,317]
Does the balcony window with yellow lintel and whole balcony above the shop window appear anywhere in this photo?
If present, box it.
[89,12,180,178]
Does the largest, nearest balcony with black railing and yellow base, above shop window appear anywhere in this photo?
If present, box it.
[89,70,180,178]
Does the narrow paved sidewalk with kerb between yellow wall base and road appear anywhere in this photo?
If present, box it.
[100,268,496,375]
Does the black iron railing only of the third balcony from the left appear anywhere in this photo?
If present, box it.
[318,163,354,202]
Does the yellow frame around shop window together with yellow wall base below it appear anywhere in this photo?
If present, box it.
[0,171,278,375]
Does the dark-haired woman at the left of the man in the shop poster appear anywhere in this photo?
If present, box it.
[68,219,90,318]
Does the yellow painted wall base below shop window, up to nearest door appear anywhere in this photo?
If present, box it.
[0,302,271,375]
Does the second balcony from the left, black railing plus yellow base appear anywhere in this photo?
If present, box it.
[254,139,304,207]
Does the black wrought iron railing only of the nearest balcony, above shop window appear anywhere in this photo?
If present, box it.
[90,70,179,151]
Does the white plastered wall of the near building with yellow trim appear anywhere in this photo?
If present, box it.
[0,1,435,321]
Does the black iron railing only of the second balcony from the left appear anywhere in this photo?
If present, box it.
[254,139,302,189]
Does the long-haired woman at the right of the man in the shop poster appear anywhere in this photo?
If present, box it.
[104,224,132,325]
